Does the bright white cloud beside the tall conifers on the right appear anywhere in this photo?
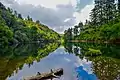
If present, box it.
[74,4,94,24]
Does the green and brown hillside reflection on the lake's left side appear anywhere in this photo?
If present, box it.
[0,43,59,80]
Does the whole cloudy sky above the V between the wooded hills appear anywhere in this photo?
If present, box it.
[0,0,94,33]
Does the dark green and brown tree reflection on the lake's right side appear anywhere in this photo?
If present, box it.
[65,43,120,80]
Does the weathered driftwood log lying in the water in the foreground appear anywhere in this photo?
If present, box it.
[24,68,63,80]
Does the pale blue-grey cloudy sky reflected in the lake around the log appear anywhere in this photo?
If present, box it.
[7,47,93,80]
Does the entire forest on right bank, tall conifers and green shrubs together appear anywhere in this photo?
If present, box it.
[64,0,120,43]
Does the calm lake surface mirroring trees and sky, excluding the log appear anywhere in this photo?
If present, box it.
[0,43,120,80]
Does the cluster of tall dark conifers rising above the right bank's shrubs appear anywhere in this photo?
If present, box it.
[90,0,116,26]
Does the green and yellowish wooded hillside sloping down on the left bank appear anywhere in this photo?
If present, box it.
[0,3,60,45]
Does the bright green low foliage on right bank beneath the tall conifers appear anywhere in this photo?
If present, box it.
[76,22,120,41]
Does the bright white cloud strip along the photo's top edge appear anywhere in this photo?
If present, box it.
[16,0,76,8]
